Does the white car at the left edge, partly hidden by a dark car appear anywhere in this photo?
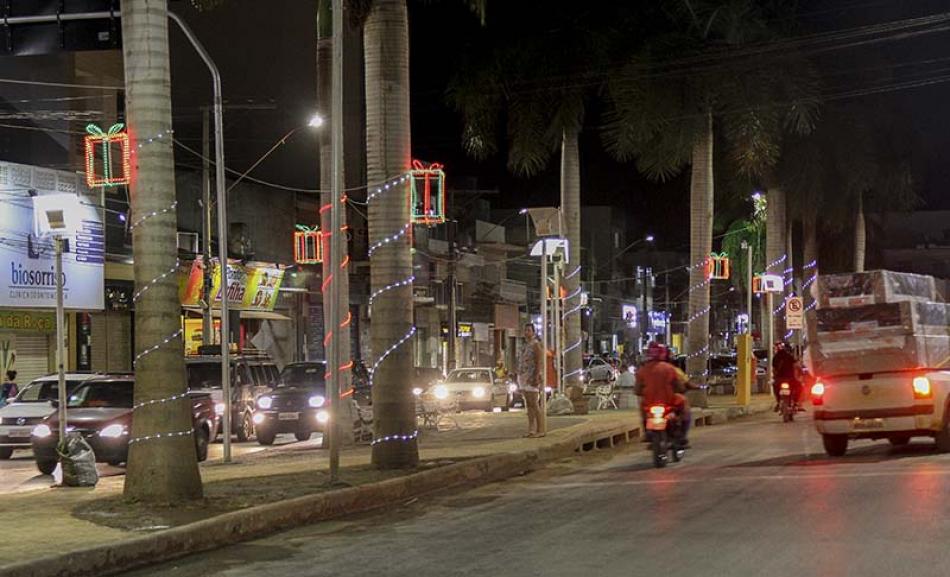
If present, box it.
[0,373,99,459]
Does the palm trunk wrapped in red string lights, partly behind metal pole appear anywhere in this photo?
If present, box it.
[317,0,353,443]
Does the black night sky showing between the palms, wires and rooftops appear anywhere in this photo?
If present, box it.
[165,0,950,254]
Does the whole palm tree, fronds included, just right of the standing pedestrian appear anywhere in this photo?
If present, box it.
[449,4,614,386]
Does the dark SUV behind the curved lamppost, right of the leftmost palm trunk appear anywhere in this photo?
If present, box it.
[185,351,280,442]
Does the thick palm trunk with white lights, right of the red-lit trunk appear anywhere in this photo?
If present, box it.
[363,0,419,469]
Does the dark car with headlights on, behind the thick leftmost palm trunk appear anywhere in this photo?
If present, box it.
[31,375,215,475]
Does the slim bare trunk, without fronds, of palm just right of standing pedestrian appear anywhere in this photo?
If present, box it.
[561,130,583,387]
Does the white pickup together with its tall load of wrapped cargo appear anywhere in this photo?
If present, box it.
[808,271,950,456]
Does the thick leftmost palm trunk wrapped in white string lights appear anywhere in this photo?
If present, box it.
[122,0,202,504]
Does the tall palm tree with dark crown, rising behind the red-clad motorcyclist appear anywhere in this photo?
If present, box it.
[604,0,814,392]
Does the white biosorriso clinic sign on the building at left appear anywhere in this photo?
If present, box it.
[0,162,105,310]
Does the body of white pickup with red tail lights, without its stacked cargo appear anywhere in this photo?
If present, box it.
[811,369,950,457]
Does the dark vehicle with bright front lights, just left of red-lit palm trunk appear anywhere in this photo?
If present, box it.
[254,361,330,445]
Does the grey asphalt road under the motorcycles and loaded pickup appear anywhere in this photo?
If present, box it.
[126,415,950,577]
